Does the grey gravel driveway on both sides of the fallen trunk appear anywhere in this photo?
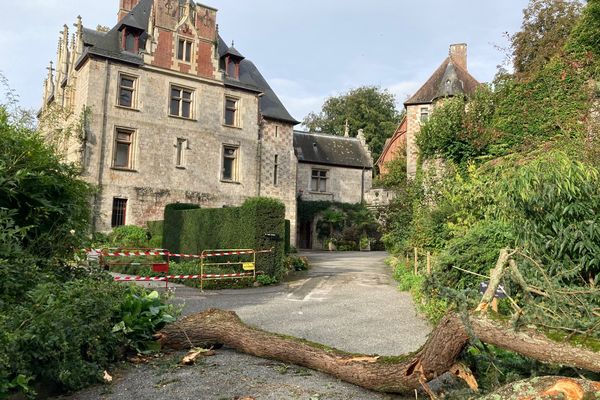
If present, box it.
[56,252,430,400]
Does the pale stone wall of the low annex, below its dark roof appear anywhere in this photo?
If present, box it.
[297,163,373,204]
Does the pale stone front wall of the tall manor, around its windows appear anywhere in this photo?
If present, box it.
[83,59,259,231]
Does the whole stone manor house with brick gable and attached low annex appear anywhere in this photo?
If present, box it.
[39,0,372,247]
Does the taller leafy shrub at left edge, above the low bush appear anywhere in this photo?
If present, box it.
[0,107,91,257]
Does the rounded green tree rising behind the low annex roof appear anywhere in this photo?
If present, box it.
[303,86,400,164]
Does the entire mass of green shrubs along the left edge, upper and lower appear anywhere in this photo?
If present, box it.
[0,101,178,397]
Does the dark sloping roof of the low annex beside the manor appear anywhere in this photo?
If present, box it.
[294,131,373,169]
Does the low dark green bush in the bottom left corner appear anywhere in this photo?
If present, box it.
[2,279,123,390]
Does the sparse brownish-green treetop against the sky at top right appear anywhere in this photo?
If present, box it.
[510,0,582,73]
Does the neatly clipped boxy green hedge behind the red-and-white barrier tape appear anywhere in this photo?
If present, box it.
[163,197,285,279]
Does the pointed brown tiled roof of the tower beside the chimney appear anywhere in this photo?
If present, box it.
[404,57,480,106]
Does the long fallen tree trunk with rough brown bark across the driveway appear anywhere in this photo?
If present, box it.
[157,309,600,393]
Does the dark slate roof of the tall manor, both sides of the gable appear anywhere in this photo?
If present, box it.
[77,0,299,125]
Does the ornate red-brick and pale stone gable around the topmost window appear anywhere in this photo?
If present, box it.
[145,0,219,79]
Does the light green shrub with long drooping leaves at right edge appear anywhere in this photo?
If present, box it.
[503,151,600,284]
